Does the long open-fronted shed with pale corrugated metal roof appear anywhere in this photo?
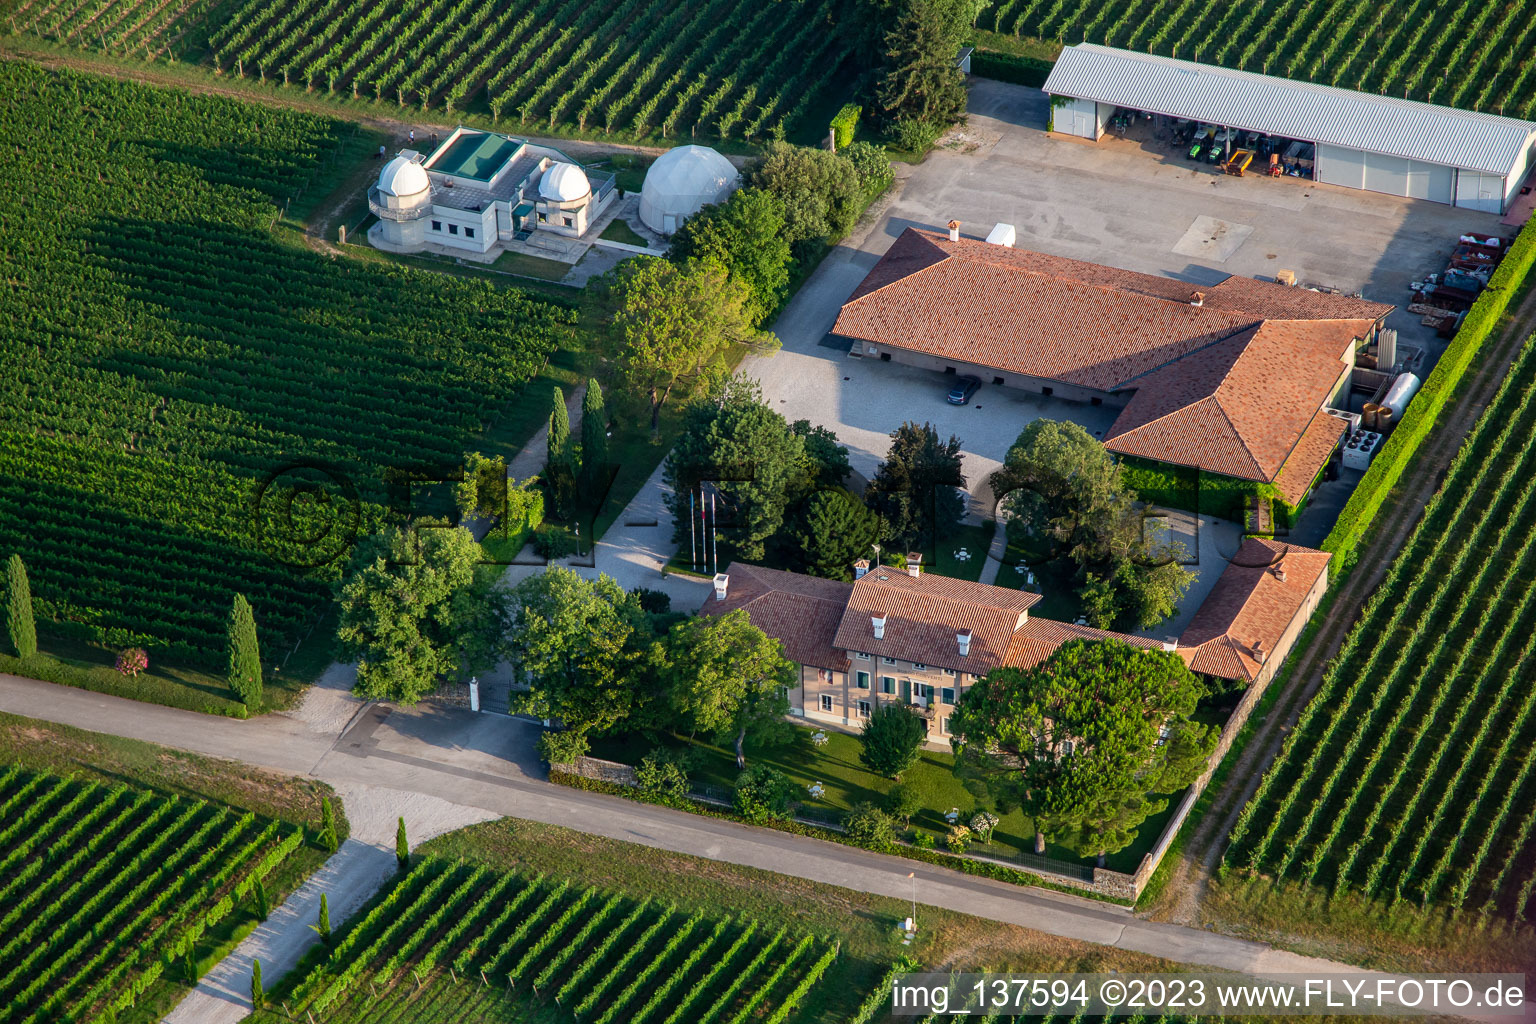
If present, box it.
[1044,43,1536,213]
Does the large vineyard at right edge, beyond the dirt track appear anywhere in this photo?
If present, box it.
[1226,330,1536,921]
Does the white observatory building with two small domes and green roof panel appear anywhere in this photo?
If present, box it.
[369,126,619,253]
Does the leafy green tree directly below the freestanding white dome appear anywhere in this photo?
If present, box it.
[667,189,791,327]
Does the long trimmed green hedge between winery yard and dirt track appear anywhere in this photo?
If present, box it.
[1322,224,1536,563]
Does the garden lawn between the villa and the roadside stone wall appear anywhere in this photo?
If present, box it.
[591,723,1178,872]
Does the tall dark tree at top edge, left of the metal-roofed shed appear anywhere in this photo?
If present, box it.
[876,0,974,129]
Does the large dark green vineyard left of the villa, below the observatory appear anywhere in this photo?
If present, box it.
[0,63,573,666]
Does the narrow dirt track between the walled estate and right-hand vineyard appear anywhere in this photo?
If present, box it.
[1150,289,1536,924]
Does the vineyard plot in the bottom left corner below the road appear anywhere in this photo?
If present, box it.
[0,766,304,1024]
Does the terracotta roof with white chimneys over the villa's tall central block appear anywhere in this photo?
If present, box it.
[834,567,1040,676]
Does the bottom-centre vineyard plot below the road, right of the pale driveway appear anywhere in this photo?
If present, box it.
[255,858,839,1024]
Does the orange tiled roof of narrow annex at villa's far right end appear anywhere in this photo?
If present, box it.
[1178,537,1332,682]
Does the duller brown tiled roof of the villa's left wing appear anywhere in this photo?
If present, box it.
[699,562,854,672]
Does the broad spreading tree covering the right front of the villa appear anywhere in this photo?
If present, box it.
[949,640,1217,857]
